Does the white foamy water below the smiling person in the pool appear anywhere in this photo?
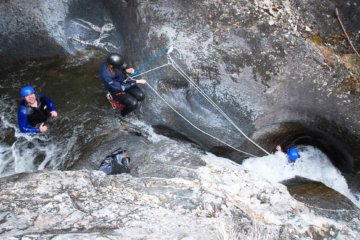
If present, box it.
[0,98,76,177]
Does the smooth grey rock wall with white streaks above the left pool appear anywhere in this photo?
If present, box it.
[0,0,123,65]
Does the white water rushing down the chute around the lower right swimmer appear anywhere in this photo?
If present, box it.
[242,146,360,207]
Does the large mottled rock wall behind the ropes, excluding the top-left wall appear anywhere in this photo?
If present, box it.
[124,0,360,172]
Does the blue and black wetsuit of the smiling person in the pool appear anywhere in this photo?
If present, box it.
[18,94,56,133]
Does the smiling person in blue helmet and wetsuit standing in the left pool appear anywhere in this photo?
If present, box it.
[18,86,57,133]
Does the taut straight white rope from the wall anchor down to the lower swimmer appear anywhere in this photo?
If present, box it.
[167,54,270,155]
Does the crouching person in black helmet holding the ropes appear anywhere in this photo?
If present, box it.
[100,53,146,117]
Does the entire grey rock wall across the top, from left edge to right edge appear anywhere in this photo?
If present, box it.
[0,0,360,172]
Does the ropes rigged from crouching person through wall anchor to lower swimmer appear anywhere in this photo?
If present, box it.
[130,47,270,157]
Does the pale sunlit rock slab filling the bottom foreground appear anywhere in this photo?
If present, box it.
[0,140,360,239]
